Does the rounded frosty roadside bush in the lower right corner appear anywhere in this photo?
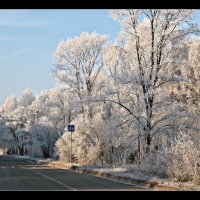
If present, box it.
[163,132,200,182]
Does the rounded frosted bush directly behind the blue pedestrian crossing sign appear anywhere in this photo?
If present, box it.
[56,115,106,164]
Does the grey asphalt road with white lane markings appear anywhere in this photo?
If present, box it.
[0,156,147,191]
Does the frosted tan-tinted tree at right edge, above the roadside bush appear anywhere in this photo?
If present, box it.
[159,37,200,143]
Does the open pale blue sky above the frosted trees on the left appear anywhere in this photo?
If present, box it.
[0,9,119,104]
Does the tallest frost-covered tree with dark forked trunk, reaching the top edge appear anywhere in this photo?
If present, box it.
[105,9,198,152]
